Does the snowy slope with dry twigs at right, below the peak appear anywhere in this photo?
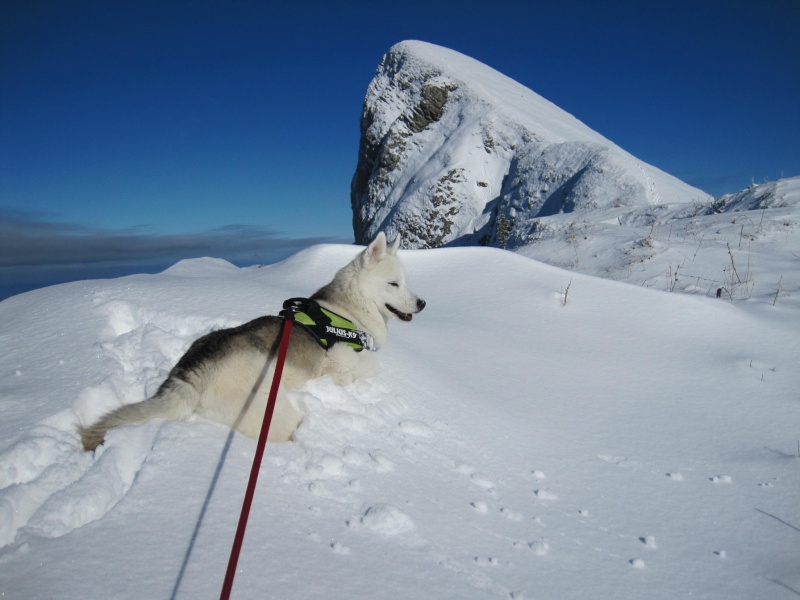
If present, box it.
[517,177,800,303]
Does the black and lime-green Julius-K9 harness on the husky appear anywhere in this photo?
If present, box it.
[280,298,377,352]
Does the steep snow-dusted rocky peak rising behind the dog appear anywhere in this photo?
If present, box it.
[351,42,708,249]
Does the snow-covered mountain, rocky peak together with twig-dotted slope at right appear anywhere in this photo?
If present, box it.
[352,41,800,299]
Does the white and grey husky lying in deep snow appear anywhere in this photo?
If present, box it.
[79,232,425,450]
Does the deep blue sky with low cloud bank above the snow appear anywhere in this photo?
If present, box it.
[0,0,800,298]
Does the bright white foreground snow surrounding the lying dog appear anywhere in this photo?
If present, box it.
[0,233,800,600]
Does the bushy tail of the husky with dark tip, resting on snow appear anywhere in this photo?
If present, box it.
[78,377,200,451]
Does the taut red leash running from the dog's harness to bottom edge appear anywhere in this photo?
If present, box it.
[219,310,293,600]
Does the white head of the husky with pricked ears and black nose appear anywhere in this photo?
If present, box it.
[360,232,425,321]
